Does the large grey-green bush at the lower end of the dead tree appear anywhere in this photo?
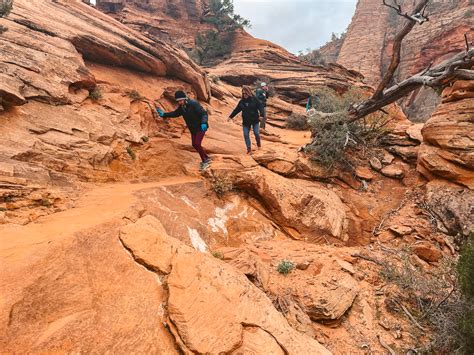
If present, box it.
[306,87,389,169]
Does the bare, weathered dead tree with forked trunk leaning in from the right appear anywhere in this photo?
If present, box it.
[349,0,474,122]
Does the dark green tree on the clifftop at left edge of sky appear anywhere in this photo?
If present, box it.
[189,0,250,64]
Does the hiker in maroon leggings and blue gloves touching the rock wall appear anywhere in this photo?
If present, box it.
[156,91,211,170]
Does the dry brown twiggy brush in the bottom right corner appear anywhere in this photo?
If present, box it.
[380,245,474,354]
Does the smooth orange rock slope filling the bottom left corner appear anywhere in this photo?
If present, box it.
[0,218,178,354]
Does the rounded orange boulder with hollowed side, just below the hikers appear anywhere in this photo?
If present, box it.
[211,157,346,241]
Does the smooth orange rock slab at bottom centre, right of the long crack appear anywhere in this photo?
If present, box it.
[121,216,330,354]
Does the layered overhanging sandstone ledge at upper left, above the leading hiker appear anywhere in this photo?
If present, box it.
[0,0,209,105]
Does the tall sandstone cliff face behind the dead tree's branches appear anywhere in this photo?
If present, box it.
[337,0,474,121]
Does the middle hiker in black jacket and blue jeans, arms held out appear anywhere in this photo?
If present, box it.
[229,86,264,154]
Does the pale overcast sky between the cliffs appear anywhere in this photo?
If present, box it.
[234,0,357,53]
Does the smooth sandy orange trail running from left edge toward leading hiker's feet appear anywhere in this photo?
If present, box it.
[0,177,200,280]
